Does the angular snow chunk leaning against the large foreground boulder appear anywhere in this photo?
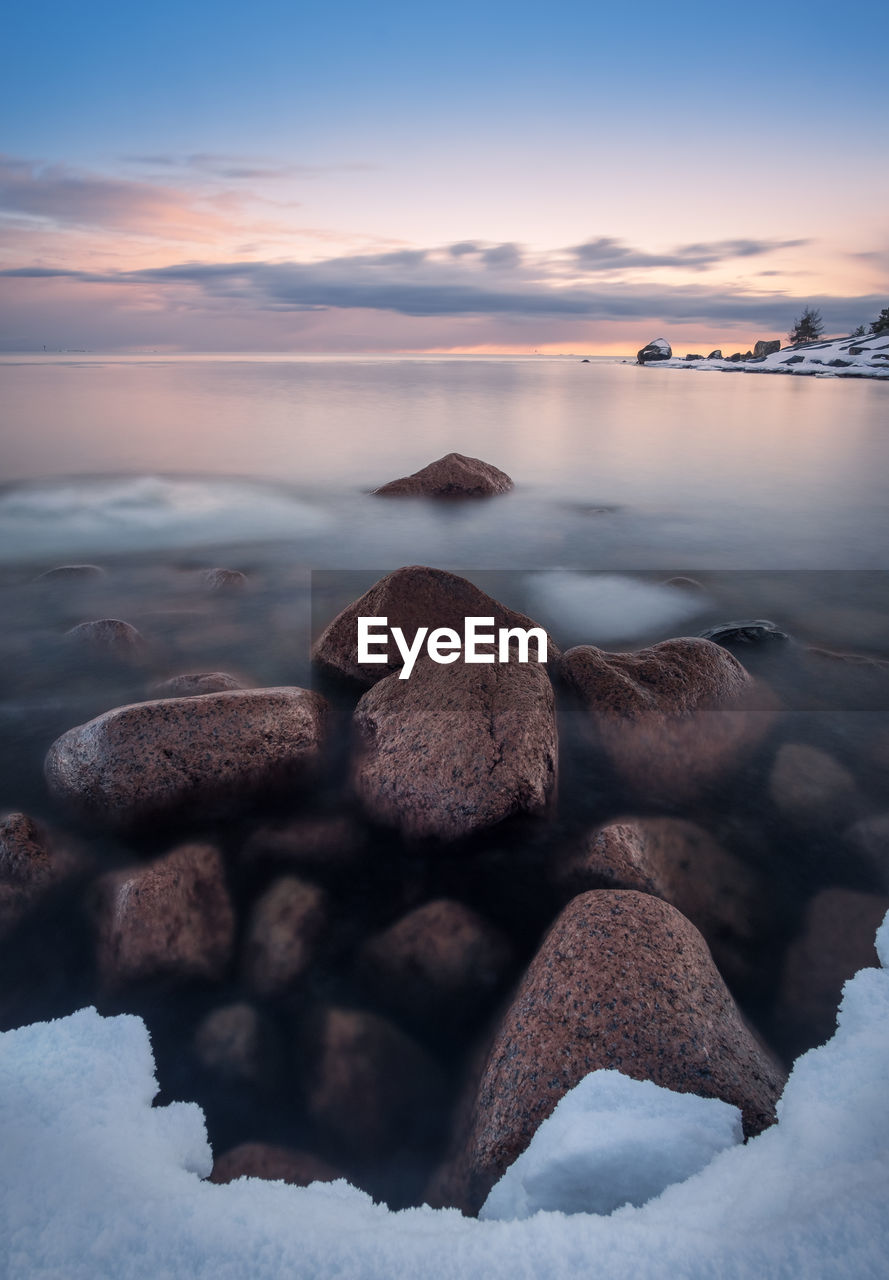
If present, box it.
[478,1070,743,1221]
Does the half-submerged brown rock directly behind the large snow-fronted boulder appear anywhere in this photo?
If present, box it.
[550,818,770,983]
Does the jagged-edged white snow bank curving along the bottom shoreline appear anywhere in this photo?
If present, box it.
[0,916,889,1280]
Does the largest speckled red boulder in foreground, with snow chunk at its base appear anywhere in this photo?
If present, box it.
[452,891,783,1212]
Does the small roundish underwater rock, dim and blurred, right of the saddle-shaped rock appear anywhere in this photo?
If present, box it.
[769,742,861,828]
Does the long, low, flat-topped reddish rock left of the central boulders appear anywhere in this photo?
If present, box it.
[45,689,326,828]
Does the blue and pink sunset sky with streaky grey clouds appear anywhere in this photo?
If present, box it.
[0,0,889,355]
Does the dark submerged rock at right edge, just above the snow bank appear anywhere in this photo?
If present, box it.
[775,888,889,1055]
